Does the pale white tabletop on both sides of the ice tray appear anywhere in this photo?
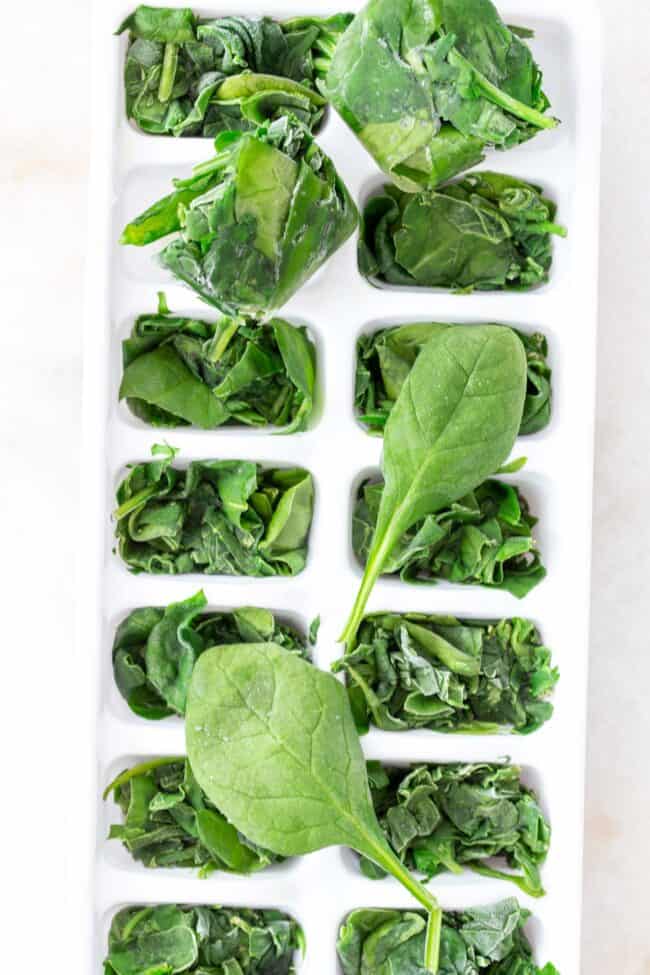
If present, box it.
[0,0,650,975]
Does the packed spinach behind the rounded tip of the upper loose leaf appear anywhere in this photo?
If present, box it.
[354,322,551,436]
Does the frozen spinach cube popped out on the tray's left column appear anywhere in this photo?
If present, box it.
[121,118,358,318]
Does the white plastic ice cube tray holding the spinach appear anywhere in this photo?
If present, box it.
[77,0,600,975]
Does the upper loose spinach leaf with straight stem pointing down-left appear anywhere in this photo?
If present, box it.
[341,325,526,640]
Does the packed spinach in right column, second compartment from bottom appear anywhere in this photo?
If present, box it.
[360,762,551,897]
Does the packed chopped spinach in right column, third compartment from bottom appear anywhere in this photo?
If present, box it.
[334,613,559,734]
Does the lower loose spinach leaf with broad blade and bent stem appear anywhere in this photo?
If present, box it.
[185,643,440,973]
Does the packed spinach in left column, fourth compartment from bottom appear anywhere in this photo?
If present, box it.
[114,445,313,576]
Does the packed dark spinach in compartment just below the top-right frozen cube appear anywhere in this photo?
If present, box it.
[358,172,566,292]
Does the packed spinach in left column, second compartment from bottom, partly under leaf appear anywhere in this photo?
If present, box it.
[104,758,283,877]
